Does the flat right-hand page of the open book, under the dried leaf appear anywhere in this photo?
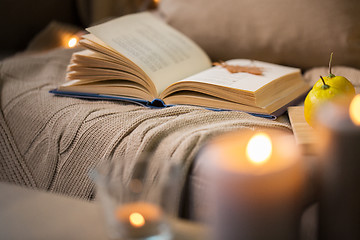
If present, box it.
[179,59,300,92]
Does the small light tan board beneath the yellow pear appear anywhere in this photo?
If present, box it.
[288,106,315,155]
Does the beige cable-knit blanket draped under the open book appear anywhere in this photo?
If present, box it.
[0,49,360,216]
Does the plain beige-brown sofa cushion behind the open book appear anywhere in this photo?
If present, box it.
[159,0,360,69]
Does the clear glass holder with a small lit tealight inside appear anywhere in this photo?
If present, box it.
[91,158,171,240]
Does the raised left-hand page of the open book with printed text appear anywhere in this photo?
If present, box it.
[87,12,211,94]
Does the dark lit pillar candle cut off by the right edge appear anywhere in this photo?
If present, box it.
[318,95,360,240]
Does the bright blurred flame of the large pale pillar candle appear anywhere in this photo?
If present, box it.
[246,133,272,165]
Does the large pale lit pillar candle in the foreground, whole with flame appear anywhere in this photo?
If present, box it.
[199,131,304,240]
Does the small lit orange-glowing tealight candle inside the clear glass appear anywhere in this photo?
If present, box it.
[115,201,170,239]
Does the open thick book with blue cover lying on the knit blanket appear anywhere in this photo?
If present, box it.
[51,12,309,118]
